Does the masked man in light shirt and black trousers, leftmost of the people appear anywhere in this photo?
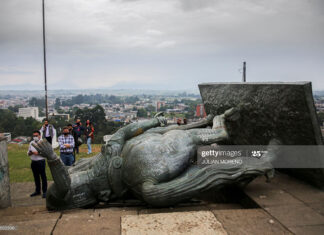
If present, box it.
[27,131,47,198]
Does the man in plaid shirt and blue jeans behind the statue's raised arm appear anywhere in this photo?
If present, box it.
[58,127,75,166]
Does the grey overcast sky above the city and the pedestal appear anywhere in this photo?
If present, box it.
[0,0,324,90]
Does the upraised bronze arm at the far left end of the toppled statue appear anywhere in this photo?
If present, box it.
[33,139,71,196]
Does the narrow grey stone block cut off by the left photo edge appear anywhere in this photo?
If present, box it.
[0,137,11,208]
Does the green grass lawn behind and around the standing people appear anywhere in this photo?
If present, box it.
[8,144,101,183]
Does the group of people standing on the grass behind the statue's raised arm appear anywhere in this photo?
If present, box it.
[27,118,94,198]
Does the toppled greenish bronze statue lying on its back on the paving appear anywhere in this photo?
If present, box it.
[34,109,275,210]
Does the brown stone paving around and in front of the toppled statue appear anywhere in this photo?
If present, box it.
[0,174,324,234]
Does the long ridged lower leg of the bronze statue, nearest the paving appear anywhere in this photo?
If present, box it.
[140,140,280,206]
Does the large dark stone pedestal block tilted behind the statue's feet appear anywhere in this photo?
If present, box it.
[199,82,324,189]
